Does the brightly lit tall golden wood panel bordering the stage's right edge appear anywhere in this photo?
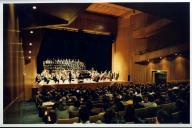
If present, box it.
[113,15,131,80]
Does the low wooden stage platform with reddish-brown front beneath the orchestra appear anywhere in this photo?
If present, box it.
[32,81,129,95]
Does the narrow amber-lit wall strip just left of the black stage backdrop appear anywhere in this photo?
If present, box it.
[22,30,43,100]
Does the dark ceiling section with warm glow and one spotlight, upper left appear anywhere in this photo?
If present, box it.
[15,3,89,29]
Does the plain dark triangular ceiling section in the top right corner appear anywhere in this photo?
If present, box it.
[117,2,190,24]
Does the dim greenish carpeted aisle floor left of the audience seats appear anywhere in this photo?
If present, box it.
[3,101,43,124]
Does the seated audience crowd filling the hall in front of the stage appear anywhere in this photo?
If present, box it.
[35,83,190,123]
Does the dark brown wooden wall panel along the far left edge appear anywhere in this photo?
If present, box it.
[3,4,24,111]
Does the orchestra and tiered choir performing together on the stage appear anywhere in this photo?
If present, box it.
[36,59,119,85]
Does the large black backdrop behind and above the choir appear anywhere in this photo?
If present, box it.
[37,29,113,73]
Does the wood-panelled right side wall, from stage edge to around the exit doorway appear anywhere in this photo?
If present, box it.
[112,13,189,83]
